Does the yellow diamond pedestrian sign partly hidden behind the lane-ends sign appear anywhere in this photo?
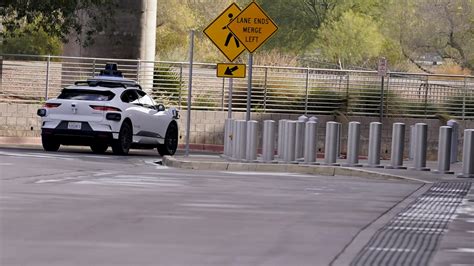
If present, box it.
[204,3,245,61]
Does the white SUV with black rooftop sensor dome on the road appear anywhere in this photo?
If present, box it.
[38,64,179,155]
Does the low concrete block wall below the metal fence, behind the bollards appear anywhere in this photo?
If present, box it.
[0,103,474,160]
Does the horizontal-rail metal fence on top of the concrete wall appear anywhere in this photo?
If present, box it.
[0,55,474,119]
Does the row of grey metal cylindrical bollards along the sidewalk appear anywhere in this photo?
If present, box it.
[224,116,474,177]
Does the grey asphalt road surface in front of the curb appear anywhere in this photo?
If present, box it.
[0,148,462,266]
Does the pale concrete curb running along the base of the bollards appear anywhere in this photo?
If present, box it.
[162,156,431,183]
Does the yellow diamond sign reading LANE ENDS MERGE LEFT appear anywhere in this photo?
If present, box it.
[227,2,278,53]
